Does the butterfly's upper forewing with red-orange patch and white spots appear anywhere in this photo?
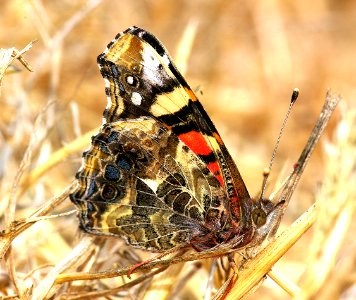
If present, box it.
[98,27,250,209]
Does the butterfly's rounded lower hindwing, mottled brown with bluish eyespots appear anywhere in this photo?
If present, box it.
[70,118,226,251]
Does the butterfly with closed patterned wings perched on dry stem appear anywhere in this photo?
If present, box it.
[70,26,286,258]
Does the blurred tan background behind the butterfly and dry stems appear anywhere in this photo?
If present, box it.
[0,0,356,299]
